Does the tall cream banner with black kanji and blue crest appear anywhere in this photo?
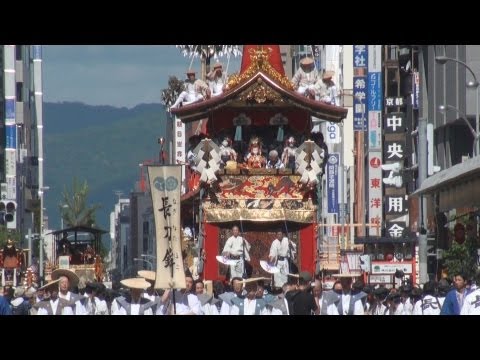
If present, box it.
[148,165,185,289]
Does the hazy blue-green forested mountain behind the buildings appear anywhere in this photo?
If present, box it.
[43,102,166,245]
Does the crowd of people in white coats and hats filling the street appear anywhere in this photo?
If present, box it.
[0,262,480,315]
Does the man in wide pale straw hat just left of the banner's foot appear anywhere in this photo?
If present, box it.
[110,278,155,315]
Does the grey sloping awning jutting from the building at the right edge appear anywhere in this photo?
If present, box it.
[410,156,480,211]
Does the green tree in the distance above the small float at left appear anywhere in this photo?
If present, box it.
[58,178,101,227]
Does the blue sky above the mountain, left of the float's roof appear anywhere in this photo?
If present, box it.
[43,45,240,108]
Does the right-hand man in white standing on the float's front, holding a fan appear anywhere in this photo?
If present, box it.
[268,231,297,288]
